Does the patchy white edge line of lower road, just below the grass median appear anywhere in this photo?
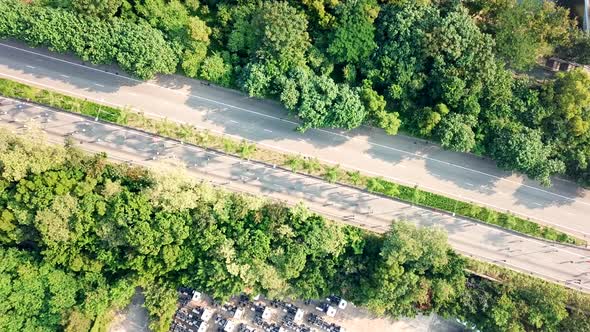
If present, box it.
[10,96,587,257]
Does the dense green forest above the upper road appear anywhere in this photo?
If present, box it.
[0,0,590,186]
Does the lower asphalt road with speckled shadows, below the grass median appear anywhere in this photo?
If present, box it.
[0,100,590,292]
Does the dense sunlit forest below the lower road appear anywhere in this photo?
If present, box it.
[0,128,590,332]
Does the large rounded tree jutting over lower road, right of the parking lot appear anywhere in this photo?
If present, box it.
[361,222,465,317]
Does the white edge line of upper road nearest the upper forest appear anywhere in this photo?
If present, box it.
[0,43,590,208]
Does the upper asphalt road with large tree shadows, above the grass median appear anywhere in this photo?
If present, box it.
[0,41,590,240]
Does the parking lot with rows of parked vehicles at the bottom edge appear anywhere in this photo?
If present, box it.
[170,288,461,332]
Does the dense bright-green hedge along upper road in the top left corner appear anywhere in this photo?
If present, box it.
[0,0,178,79]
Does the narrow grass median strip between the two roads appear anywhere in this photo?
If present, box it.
[0,78,586,245]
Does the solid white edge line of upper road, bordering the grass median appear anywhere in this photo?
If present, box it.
[0,70,590,235]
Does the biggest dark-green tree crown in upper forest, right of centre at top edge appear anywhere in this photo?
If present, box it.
[364,2,498,134]
